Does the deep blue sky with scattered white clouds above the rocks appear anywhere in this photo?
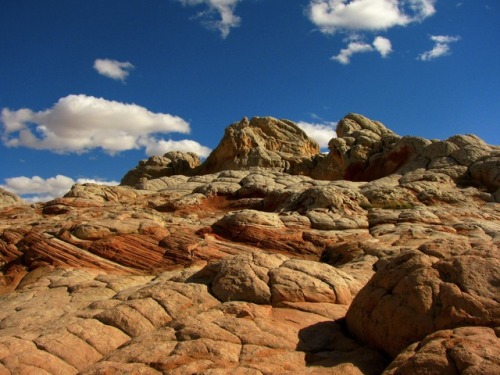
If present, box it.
[0,0,500,200]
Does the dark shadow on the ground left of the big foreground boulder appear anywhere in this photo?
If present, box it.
[297,319,390,375]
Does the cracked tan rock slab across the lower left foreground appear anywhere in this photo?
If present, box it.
[0,264,386,374]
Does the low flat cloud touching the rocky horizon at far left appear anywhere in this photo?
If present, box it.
[0,175,119,203]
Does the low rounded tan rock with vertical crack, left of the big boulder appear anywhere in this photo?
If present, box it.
[208,254,361,306]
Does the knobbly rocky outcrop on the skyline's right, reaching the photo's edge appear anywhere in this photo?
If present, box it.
[324,113,500,195]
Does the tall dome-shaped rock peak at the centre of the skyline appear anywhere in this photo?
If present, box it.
[199,117,319,174]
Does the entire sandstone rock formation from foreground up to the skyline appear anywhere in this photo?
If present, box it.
[0,114,500,374]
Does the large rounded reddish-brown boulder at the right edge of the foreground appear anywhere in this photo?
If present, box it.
[346,248,500,357]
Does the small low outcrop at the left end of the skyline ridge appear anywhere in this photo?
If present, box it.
[120,151,201,186]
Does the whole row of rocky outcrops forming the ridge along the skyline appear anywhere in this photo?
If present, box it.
[121,113,500,201]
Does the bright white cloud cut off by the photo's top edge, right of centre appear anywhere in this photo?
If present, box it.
[307,0,436,34]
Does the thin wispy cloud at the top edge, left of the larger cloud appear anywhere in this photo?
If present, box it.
[177,0,241,39]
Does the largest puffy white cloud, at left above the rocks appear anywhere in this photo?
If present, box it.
[0,95,211,154]
